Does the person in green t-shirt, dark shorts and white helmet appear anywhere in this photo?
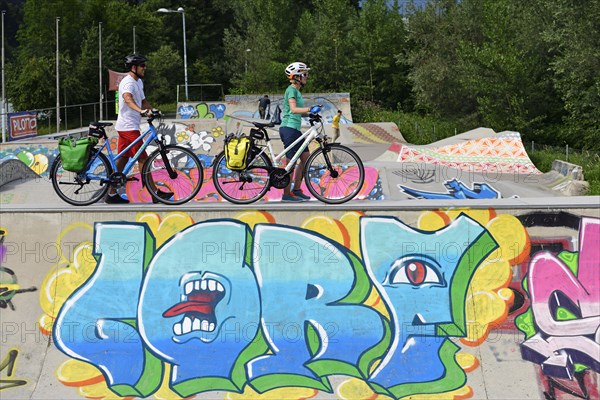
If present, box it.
[279,62,310,201]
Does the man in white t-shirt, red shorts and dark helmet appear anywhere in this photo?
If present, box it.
[106,54,173,204]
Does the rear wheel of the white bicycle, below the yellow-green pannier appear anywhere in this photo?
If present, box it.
[213,152,272,204]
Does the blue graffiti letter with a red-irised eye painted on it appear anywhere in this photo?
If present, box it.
[361,216,497,397]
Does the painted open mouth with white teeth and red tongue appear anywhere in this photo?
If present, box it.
[163,274,227,341]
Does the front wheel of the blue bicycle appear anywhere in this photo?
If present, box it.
[142,145,204,204]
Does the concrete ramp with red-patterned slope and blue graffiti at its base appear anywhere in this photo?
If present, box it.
[371,128,588,200]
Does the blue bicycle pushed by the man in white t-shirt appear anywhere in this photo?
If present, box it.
[50,110,204,206]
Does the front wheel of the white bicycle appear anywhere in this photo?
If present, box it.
[304,143,365,204]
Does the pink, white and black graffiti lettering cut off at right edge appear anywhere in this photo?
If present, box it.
[515,218,600,395]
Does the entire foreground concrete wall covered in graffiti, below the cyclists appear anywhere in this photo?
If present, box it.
[0,209,600,399]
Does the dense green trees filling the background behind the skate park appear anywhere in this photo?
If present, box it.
[0,0,600,155]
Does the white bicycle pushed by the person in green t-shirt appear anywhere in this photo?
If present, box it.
[212,108,365,204]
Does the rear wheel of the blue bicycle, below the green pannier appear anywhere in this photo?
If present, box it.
[50,152,113,206]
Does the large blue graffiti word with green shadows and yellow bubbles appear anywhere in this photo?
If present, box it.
[48,212,523,398]
